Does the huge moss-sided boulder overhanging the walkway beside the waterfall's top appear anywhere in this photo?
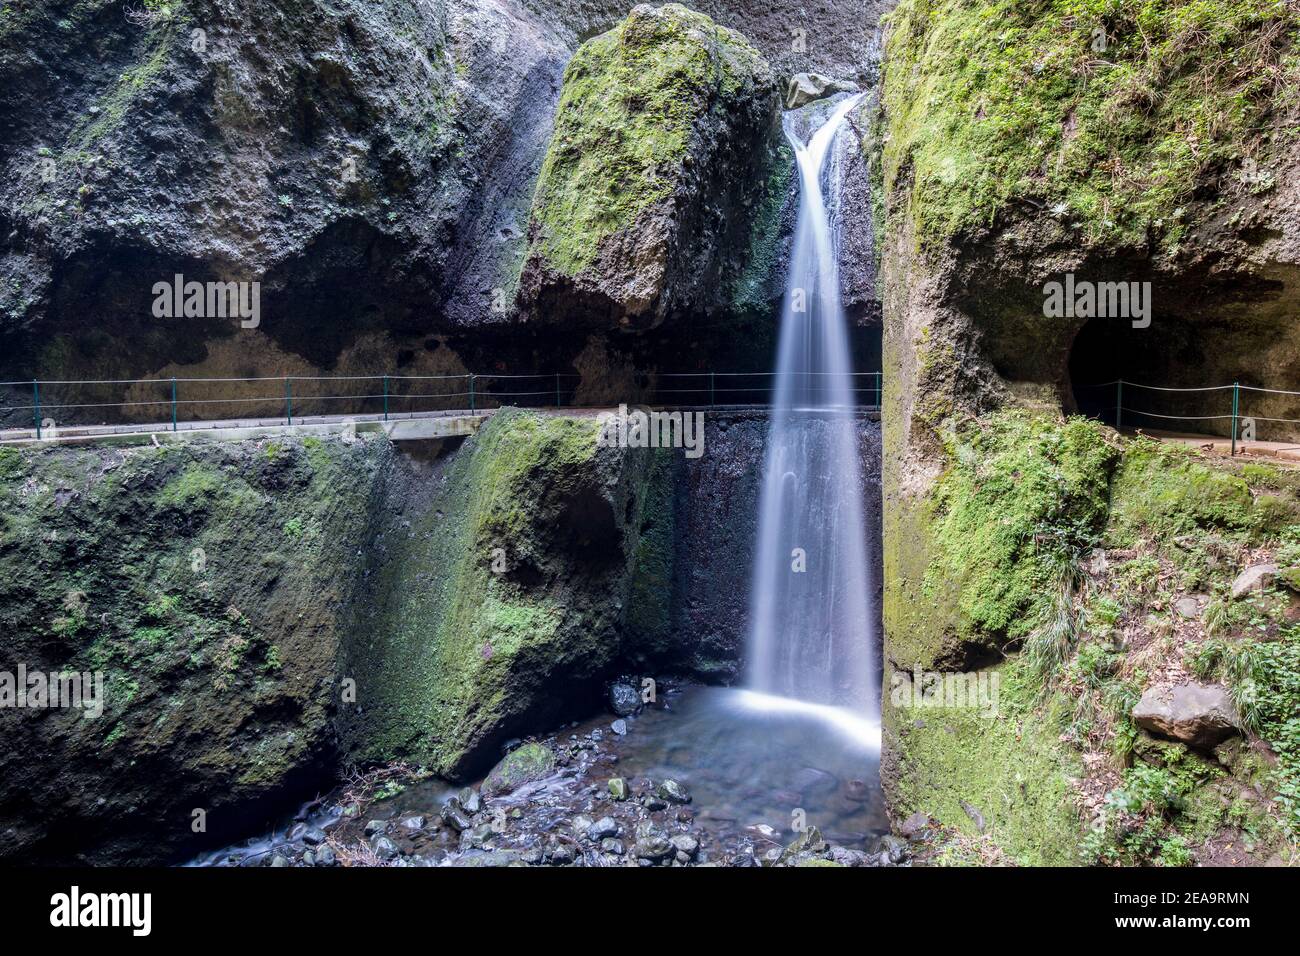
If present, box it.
[520,4,777,328]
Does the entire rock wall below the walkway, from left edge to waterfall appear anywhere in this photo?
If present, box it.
[0,408,879,864]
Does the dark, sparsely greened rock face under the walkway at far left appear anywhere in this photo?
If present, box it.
[0,438,391,864]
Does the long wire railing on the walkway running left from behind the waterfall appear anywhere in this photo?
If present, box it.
[0,371,883,438]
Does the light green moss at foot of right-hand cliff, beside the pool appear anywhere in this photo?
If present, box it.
[889,662,1082,866]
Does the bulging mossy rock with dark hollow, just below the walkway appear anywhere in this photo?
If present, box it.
[341,410,649,777]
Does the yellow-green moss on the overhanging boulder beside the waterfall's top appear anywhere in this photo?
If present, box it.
[532,4,762,276]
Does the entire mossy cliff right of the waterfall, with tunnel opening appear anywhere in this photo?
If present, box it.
[867,0,1300,865]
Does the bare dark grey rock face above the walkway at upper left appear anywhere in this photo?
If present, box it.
[0,0,883,403]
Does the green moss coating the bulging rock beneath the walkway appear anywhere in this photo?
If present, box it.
[348,408,634,775]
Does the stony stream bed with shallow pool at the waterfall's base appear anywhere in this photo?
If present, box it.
[190,685,906,866]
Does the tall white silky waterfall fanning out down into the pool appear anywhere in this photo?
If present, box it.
[749,96,878,715]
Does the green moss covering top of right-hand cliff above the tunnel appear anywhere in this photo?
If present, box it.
[883,0,1296,246]
